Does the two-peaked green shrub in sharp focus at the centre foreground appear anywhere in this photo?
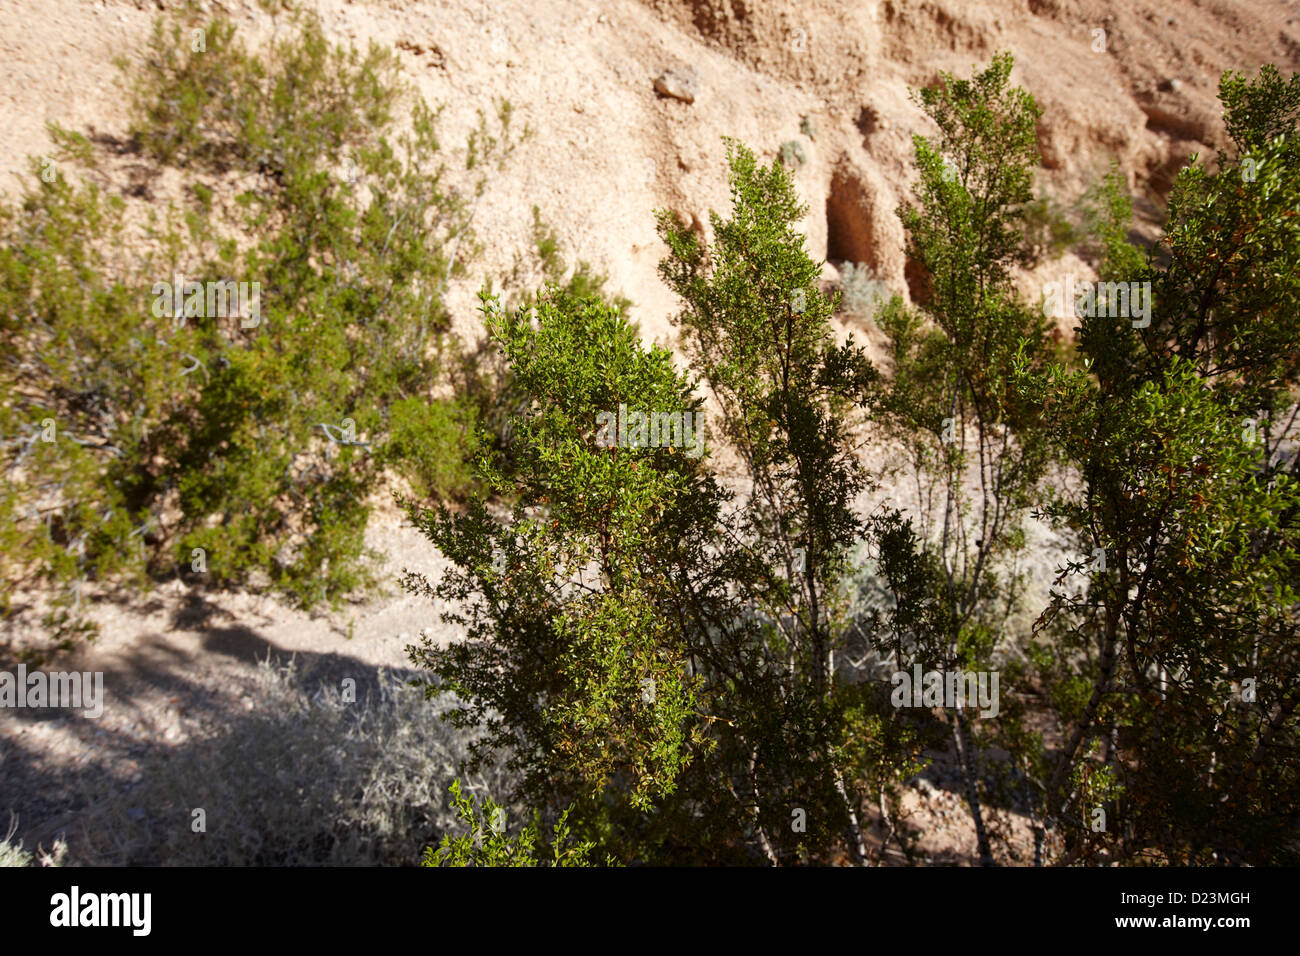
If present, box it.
[406,143,896,862]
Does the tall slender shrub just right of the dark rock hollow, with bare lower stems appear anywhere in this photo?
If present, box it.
[871,53,1050,865]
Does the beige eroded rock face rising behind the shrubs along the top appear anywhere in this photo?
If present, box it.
[0,0,1300,351]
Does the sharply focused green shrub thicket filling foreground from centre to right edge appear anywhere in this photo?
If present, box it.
[406,55,1300,865]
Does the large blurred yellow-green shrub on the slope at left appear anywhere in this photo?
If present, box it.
[0,3,527,658]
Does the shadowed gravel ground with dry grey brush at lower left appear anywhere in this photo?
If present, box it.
[0,598,441,865]
